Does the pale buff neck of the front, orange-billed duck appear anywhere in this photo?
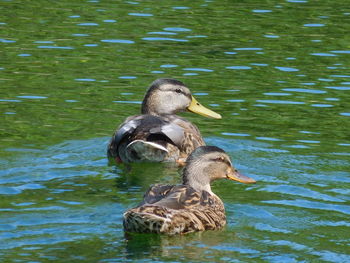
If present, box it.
[182,164,214,194]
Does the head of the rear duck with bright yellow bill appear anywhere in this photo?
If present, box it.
[141,79,221,119]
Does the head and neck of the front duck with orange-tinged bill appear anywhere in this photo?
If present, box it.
[182,146,256,193]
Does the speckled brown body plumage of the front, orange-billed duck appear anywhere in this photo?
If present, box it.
[124,185,226,235]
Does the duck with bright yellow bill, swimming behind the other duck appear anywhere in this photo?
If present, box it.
[107,79,221,163]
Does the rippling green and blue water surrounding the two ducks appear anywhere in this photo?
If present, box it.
[0,0,350,262]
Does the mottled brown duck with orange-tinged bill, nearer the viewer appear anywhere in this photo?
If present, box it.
[123,146,256,235]
